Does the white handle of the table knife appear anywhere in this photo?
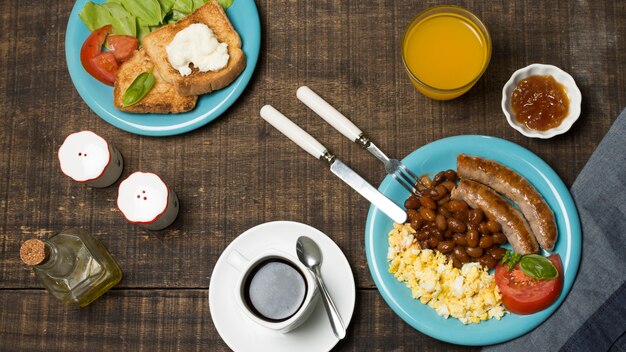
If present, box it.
[261,105,327,159]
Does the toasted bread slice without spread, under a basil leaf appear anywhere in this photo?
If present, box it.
[113,49,198,114]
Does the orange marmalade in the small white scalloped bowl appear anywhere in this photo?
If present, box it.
[511,76,569,131]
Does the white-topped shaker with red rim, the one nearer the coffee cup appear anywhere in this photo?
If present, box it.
[117,172,178,230]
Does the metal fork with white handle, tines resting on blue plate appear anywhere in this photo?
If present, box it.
[296,86,426,197]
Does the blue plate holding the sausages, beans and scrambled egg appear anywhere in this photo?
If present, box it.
[365,136,581,346]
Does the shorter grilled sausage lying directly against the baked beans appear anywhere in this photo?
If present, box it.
[450,179,539,254]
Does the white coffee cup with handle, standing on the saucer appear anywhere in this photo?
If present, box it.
[227,249,319,333]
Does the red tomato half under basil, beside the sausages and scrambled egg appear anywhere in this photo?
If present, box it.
[496,254,563,314]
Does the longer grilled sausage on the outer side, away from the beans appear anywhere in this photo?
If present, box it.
[457,154,558,251]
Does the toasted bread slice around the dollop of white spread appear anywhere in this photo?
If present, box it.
[142,0,246,95]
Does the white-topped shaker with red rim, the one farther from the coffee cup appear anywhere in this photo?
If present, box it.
[59,131,124,188]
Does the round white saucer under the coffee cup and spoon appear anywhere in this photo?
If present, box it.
[209,221,355,352]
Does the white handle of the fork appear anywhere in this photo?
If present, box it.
[296,86,363,142]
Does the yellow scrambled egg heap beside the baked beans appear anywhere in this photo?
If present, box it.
[387,224,506,324]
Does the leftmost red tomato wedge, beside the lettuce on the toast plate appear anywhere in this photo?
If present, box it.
[80,25,117,86]
